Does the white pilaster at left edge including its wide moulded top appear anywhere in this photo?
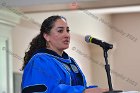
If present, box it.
[0,9,19,93]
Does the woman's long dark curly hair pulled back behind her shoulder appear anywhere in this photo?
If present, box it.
[22,15,66,70]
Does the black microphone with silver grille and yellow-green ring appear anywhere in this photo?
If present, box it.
[85,35,113,49]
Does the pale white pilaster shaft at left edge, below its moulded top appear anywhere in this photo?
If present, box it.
[0,23,13,93]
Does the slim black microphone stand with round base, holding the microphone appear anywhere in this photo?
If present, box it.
[100,42,122,93]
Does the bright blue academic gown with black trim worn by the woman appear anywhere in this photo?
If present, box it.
[21,50,91,93]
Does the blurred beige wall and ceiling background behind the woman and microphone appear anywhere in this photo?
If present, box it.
[0,0,140,93]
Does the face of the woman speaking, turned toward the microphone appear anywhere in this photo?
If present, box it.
[45,19,70,51]
